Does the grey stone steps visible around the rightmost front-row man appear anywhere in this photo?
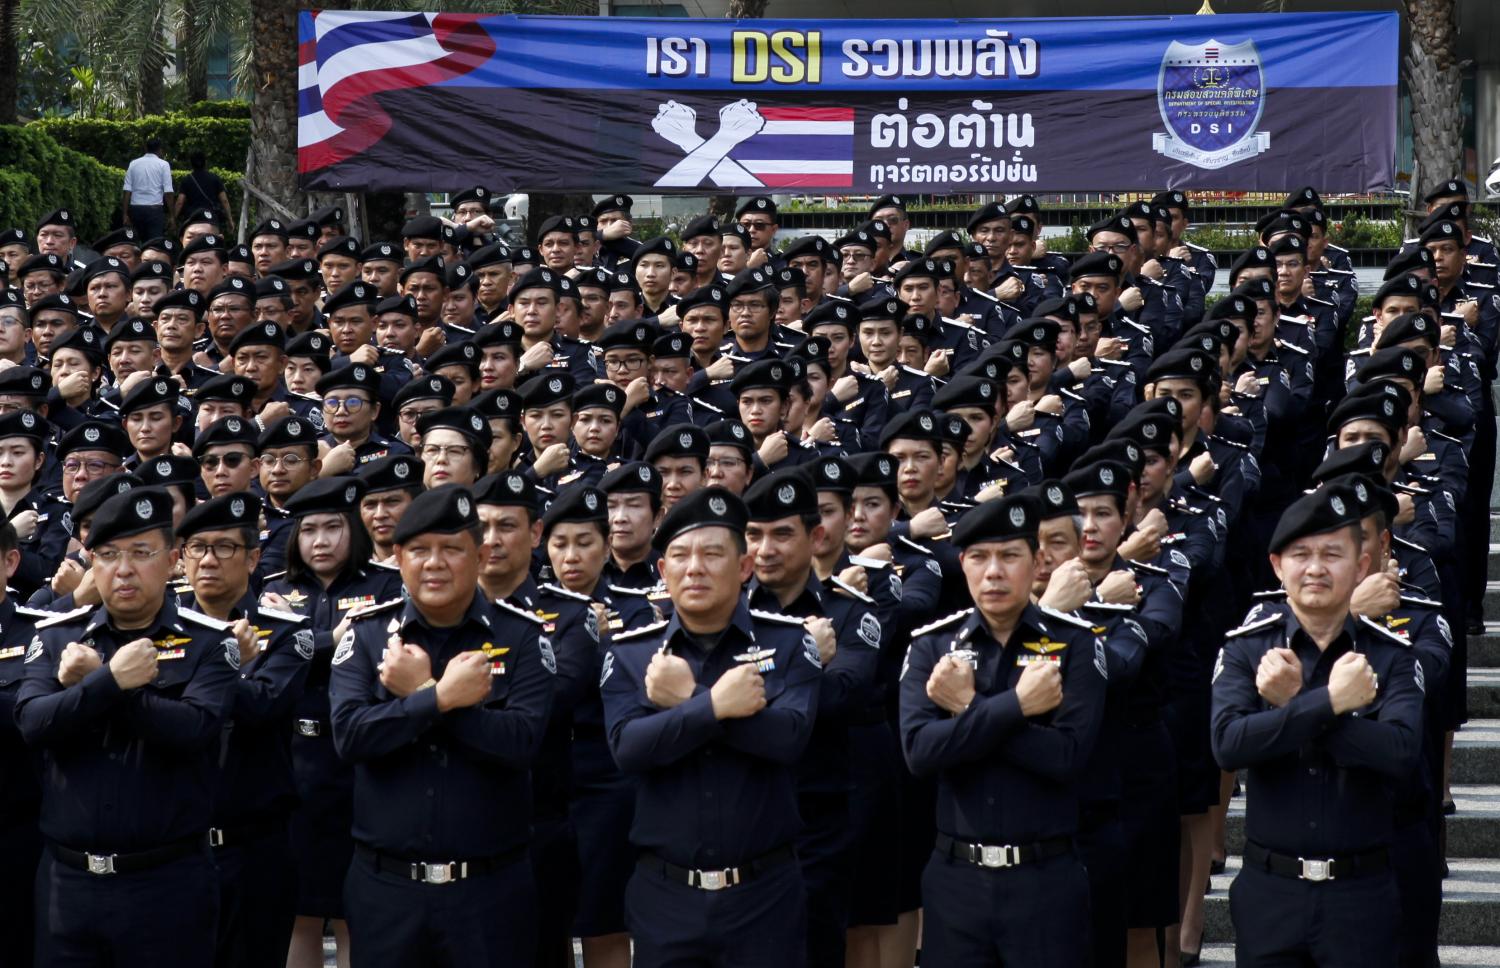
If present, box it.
[1202,525,1500,966]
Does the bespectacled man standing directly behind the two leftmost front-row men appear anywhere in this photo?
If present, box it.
[177,491,314,965]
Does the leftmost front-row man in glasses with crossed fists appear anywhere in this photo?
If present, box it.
[17,488,240,968]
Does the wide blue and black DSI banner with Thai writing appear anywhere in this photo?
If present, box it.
[297,11,1400,194]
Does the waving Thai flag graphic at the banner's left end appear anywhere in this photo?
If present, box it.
[297,11,495,173]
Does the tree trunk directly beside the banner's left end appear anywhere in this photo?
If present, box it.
[251,0,300,212]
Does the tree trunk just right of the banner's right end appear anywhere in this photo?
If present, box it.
[1406,0,1464,234]
